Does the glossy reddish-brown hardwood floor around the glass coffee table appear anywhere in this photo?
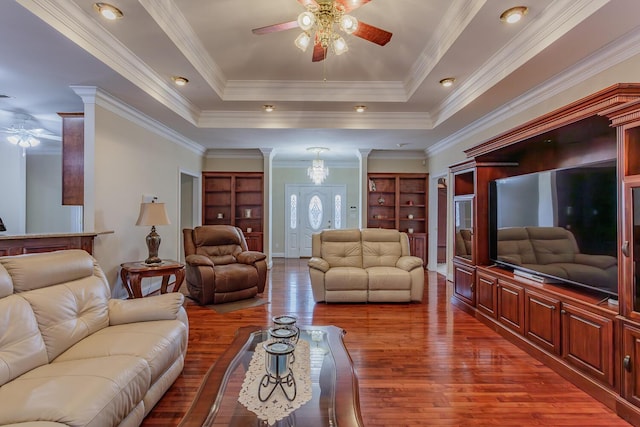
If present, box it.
[143,259,629,427]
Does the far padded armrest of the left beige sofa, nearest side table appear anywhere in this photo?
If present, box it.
[109,292,184,326]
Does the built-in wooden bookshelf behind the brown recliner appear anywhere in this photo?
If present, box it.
[202,172,264,251]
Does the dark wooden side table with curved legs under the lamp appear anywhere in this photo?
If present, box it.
[120,259,184,298]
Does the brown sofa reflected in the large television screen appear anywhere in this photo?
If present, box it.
[497,227,618,291]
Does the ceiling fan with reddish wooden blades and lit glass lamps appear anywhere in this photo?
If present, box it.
[251,0,393,62]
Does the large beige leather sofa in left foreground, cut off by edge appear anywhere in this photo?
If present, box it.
[0,250,188,427]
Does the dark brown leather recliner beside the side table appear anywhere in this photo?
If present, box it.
[182,225,267,305]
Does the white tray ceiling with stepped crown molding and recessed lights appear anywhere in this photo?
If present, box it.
[0,0,640,161]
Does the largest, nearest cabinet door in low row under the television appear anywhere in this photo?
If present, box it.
[561,304,614,386]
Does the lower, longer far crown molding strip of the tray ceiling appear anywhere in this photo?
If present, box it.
[198,111,433,130]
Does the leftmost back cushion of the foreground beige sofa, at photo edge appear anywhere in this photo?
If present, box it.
[0,295,49,386]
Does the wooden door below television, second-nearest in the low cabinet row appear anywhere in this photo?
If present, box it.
[524,290,560,355]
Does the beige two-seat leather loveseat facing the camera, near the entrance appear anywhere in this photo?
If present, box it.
[309,228,424,302]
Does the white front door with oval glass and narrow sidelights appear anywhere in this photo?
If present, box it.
[284,184,347,258]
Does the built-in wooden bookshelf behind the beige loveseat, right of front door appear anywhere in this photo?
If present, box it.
[367,173,429,265]
